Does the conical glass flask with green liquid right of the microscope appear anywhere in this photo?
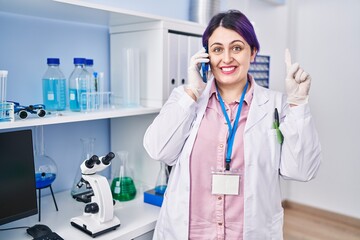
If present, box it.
[111,151,136,201]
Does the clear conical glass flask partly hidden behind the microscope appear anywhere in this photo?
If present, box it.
[71,138,95,202]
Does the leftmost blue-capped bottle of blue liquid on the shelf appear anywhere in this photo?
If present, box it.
[42,58,66,111]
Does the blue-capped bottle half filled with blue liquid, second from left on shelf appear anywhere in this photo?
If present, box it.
[69,58,91,112]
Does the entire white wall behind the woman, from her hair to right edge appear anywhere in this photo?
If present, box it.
[229,0,360,218]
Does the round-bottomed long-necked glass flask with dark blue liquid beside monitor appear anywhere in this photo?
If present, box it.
[34,126,57,189]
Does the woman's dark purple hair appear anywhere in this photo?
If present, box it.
[202,10,260,52]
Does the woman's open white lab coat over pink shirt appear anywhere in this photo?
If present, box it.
[144,80,321,240]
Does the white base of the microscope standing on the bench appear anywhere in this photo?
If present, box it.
[71,215,120,238]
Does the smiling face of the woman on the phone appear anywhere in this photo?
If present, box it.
[208,27,256,85]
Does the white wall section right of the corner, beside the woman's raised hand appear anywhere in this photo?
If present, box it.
[289,0,360,218]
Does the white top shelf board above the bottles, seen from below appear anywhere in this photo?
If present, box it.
[0,0,199,31]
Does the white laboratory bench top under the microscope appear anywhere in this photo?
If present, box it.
[0,191,160,240]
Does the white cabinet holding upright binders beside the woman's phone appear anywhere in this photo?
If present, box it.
[110,20,204,107]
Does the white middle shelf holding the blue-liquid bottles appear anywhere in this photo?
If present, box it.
[0,107,160,130]
